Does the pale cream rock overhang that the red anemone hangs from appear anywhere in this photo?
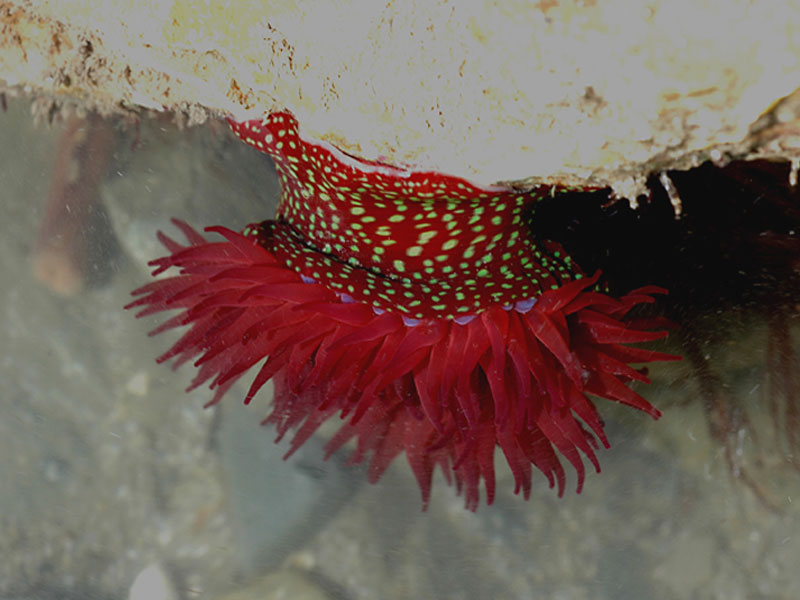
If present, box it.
[0,0,800,199]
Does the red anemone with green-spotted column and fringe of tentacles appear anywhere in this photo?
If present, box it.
[128,112,674,510]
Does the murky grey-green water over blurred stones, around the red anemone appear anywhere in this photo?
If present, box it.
[0,100,800,600]
